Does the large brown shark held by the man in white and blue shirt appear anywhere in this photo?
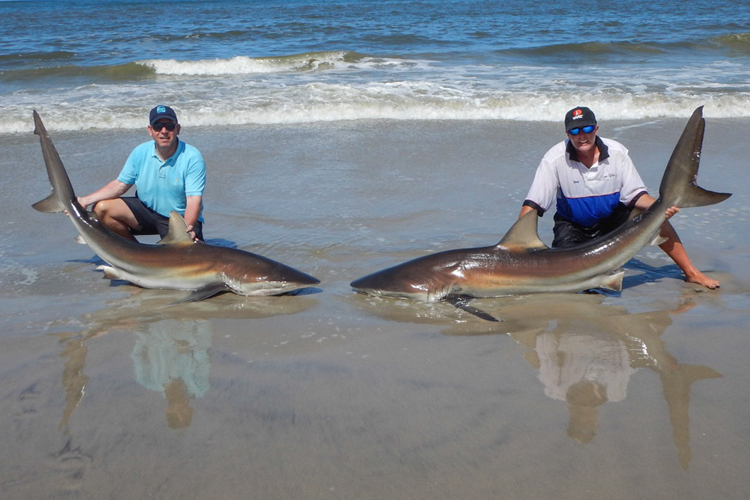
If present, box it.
[351,107,731,319]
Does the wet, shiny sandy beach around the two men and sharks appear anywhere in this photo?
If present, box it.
[0,116,750,500]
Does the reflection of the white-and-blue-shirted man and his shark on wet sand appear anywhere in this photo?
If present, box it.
[358,292,722,469]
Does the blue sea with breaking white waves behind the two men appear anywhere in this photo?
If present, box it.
[0,0,750,134]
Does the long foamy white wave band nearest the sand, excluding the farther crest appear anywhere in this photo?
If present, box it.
[0,85,750,134]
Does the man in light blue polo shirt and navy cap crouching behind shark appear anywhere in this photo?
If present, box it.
[78,106,206,241]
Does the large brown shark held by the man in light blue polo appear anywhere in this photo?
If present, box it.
[33,111,320,301]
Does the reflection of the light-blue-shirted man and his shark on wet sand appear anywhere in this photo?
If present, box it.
[57,288,315,429]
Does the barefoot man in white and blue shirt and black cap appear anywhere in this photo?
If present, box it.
[519,107,719,288]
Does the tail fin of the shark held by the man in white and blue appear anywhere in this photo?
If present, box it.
[659,106,732,208]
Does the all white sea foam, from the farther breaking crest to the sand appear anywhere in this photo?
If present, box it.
[0,69,750,134]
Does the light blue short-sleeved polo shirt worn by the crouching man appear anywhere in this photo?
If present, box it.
[117,141,206,222]
